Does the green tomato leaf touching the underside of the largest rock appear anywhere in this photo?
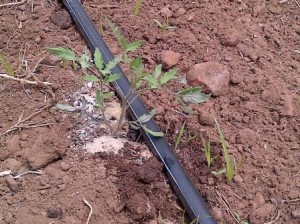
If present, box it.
[178,87,210,103]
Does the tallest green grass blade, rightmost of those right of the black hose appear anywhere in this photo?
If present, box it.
[212,116,234,182]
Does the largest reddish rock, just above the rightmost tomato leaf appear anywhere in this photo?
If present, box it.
[187,62,230,96]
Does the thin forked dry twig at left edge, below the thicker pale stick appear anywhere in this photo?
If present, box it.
[0,105,53,137]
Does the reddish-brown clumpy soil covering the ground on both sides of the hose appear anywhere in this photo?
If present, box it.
[0,0,300,224]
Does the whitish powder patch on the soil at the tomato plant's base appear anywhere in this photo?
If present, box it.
[86,136,127,154]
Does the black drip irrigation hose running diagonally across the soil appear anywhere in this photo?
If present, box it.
[63,0,216,224]
